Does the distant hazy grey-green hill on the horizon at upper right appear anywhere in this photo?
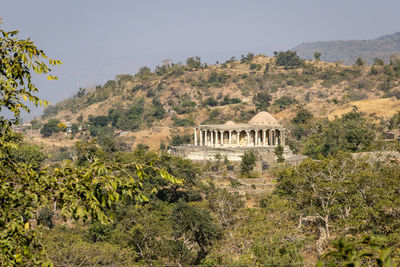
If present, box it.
[293,32,400,65]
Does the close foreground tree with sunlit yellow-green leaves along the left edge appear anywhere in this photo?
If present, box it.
[0,21,180,266]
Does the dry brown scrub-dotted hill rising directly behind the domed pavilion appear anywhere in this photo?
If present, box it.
[35,51,400,149]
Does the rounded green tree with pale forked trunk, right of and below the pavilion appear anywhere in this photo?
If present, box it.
[276,154,370,238]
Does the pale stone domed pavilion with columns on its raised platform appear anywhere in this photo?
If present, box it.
[170,111,298,163]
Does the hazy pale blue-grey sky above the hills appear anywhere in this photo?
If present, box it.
[0,0,400,119]
